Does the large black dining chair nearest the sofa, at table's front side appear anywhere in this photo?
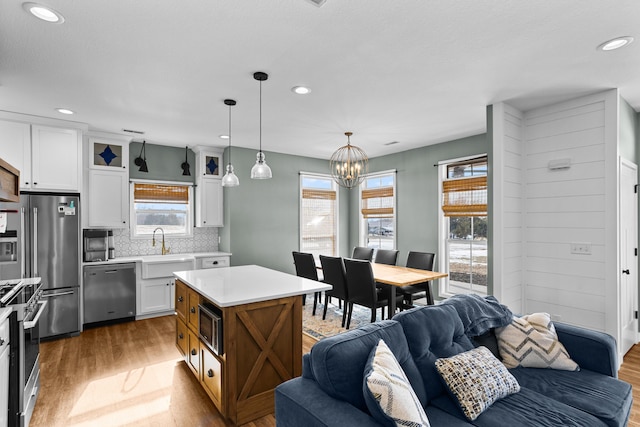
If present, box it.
[344,258,402,329]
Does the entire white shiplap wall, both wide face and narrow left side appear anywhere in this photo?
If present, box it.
[493,90,619,337]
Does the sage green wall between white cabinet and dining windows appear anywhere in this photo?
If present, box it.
[219,147,349,274]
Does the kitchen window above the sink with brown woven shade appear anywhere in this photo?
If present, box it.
[131,182,193,237]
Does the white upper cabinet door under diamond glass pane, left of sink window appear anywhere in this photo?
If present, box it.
[88,169,129,228]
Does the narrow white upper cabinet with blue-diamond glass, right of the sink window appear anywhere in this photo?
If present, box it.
[193,147,224,227]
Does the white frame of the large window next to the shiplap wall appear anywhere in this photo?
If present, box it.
[438,153,488,298]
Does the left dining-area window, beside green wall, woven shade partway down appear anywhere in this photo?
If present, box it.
[300,174,338,258]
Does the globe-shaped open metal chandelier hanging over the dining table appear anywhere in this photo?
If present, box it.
[329,132,369,188]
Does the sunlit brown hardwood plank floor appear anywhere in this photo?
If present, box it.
[31,316,640,427]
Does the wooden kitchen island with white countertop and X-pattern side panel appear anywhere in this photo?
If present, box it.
[174,265,331,424]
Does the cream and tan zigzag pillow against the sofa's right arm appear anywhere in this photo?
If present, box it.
[495,313,580,371]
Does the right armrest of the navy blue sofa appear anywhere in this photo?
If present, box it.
[554,322,618,378]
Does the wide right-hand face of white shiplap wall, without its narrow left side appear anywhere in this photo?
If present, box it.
[524,96,607,330]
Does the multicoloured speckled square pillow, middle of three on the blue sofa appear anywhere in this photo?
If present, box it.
[436,347,520,421]
